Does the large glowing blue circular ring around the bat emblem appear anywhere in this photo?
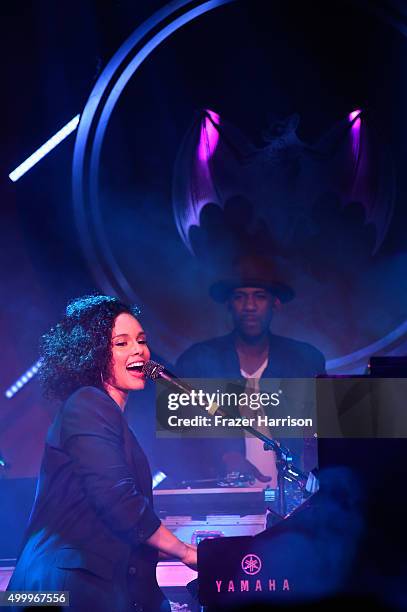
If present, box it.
[72,0,407,370]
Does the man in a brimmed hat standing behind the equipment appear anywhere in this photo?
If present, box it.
[176,257,325,486]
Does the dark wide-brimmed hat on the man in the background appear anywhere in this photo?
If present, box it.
[209,256,295,303]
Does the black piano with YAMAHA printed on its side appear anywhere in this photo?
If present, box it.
[194,368,407,610]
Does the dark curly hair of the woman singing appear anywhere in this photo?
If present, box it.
[39,295,140,400]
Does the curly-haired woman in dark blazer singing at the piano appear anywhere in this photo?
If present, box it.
[8,295,196,612]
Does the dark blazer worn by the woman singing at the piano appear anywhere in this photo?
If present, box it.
[8,387,165,612]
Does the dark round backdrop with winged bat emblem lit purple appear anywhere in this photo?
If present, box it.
[74,1,407,373]
